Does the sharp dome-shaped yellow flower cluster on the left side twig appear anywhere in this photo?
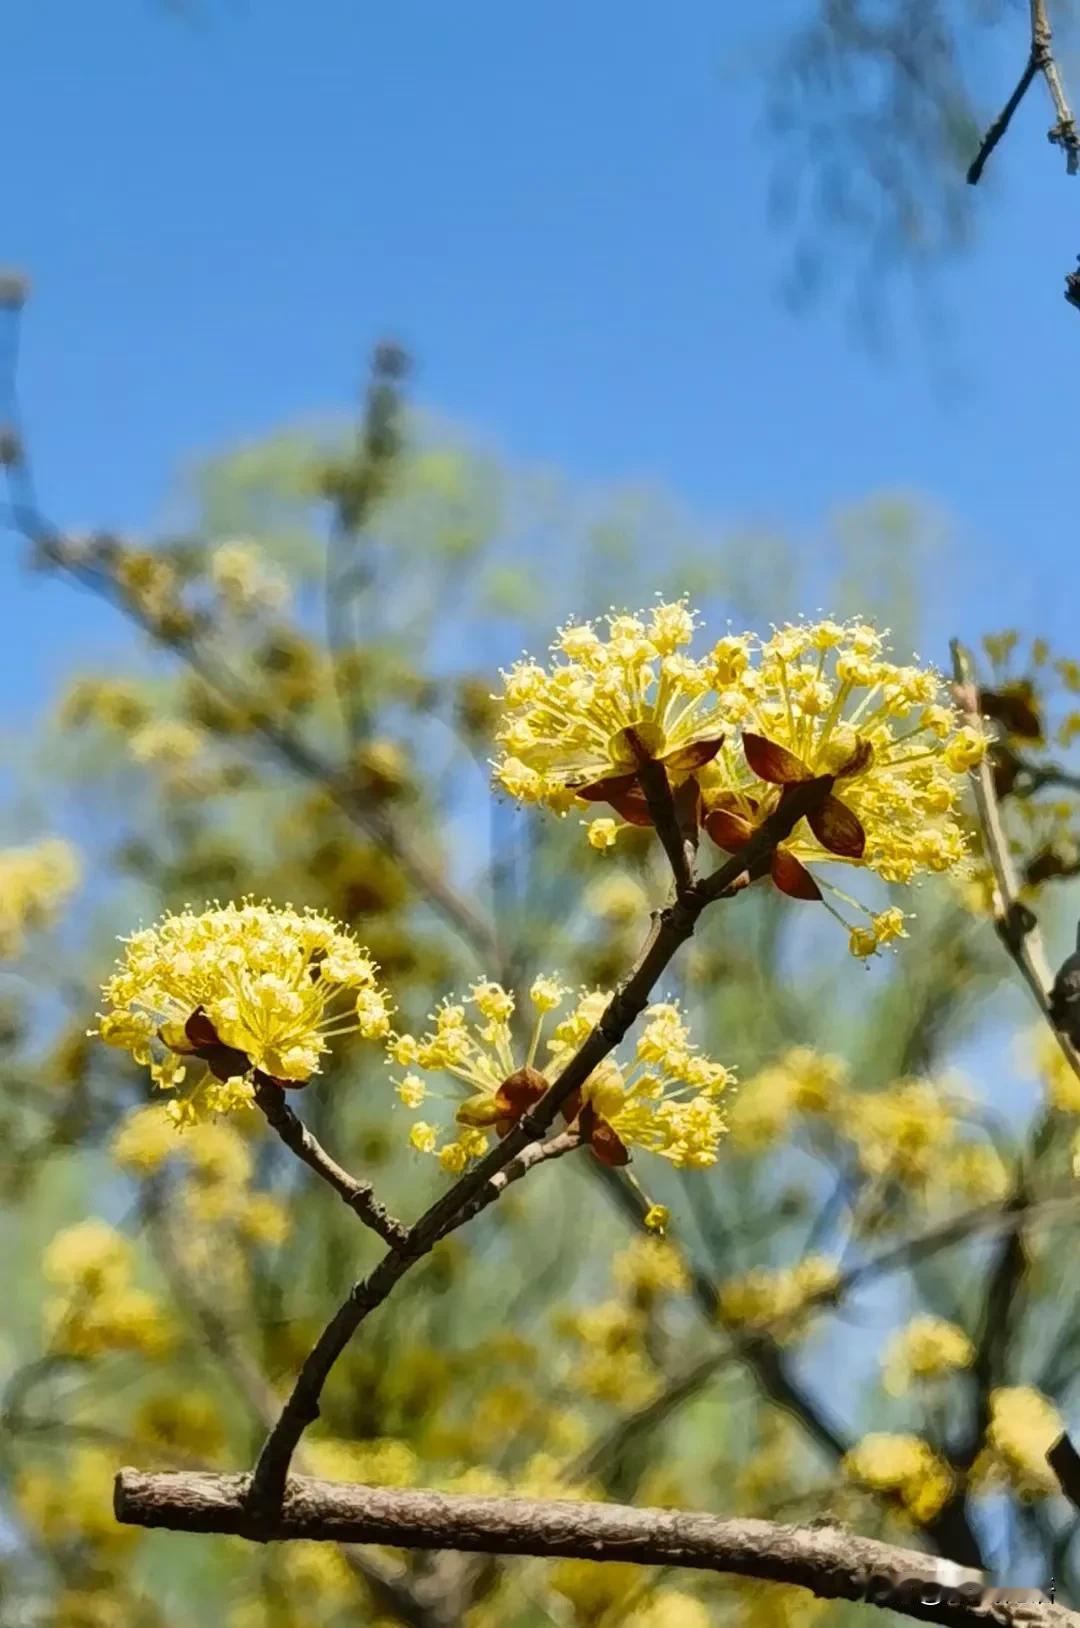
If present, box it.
[96,902,389,1125]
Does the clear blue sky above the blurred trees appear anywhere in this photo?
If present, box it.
[0,0,1080,706]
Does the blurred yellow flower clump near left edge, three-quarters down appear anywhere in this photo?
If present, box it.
[42,1221,176,1358]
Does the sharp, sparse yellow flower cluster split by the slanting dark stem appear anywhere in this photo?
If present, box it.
[388,977,731,1175]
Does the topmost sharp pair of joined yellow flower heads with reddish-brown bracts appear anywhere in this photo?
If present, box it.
[494,601,986,956]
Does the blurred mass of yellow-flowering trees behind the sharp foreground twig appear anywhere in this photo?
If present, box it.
[0,333,1080,1628]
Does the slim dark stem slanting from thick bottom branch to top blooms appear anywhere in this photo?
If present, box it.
[251,775,834,1508]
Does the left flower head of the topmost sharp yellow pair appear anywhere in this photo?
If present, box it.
[494,601,728,814]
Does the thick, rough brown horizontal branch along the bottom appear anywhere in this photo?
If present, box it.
[114,1470,1080,1628]
